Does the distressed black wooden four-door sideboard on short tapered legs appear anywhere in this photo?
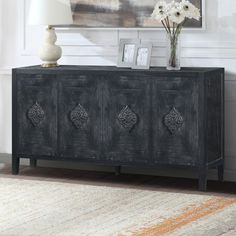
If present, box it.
[12,66,224,191]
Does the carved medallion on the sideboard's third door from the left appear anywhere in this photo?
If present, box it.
[118,106,138,131]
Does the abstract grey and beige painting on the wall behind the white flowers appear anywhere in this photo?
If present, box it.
[70,0,204,28]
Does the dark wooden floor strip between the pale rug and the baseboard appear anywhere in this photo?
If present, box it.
[0,165,236,195]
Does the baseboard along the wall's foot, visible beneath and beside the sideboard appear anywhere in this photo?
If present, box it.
[0,154,236,182]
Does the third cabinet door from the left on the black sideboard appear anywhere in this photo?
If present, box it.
[102,75,150,164]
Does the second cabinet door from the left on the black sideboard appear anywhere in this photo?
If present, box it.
[59,74,101,160]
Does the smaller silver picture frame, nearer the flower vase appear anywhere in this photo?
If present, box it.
[132,43,152,69]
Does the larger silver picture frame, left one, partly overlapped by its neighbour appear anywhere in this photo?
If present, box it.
[117,39,140,67]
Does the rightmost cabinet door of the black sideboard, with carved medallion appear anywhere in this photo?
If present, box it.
[152,78,198,166]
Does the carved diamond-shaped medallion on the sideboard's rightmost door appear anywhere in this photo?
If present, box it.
[164,107,184,134]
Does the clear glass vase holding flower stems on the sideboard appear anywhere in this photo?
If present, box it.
[166,34,181,70]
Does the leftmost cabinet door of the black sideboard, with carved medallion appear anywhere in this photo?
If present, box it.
[14,74,57,156]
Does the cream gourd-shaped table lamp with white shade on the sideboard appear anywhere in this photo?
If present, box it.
[28,0,73,68]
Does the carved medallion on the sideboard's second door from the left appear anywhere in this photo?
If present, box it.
[70,104,89,129]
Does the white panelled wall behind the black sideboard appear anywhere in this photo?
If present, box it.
[0,0,236,181]
